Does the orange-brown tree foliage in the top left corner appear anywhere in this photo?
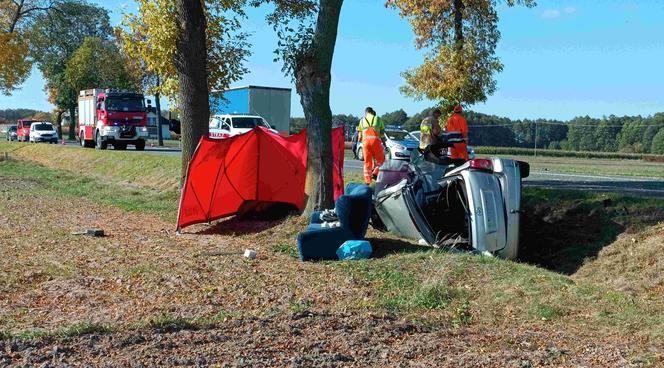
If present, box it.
[0,0,60,95]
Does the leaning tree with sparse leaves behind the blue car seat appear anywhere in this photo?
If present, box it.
[264,0,343,214]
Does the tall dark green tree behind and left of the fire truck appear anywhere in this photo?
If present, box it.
[31,0,113,139]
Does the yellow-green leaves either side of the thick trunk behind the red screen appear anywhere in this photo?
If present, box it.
[116,0,250,102]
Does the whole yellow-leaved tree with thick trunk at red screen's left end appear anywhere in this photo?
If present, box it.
[118,0,249,183]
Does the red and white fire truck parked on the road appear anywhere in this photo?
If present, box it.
[76,89,148,151]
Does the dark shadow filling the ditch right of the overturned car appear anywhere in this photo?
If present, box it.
[519,189,664,275]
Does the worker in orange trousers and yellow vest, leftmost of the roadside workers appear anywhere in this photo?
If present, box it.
[357,107,385,185]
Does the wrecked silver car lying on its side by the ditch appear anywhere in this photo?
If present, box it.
[372,134,530,259]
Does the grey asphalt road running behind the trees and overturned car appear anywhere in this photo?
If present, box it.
[58,141,664,198]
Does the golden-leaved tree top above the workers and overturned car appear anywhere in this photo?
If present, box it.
[387,0,535,111]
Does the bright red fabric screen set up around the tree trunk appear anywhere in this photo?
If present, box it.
[177,128,344,229]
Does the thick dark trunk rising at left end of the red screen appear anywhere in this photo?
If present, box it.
[174,0,210,185]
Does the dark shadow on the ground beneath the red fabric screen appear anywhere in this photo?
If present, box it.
[195,202,299,235]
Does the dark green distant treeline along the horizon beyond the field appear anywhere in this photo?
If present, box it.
[291,109,664,154]
